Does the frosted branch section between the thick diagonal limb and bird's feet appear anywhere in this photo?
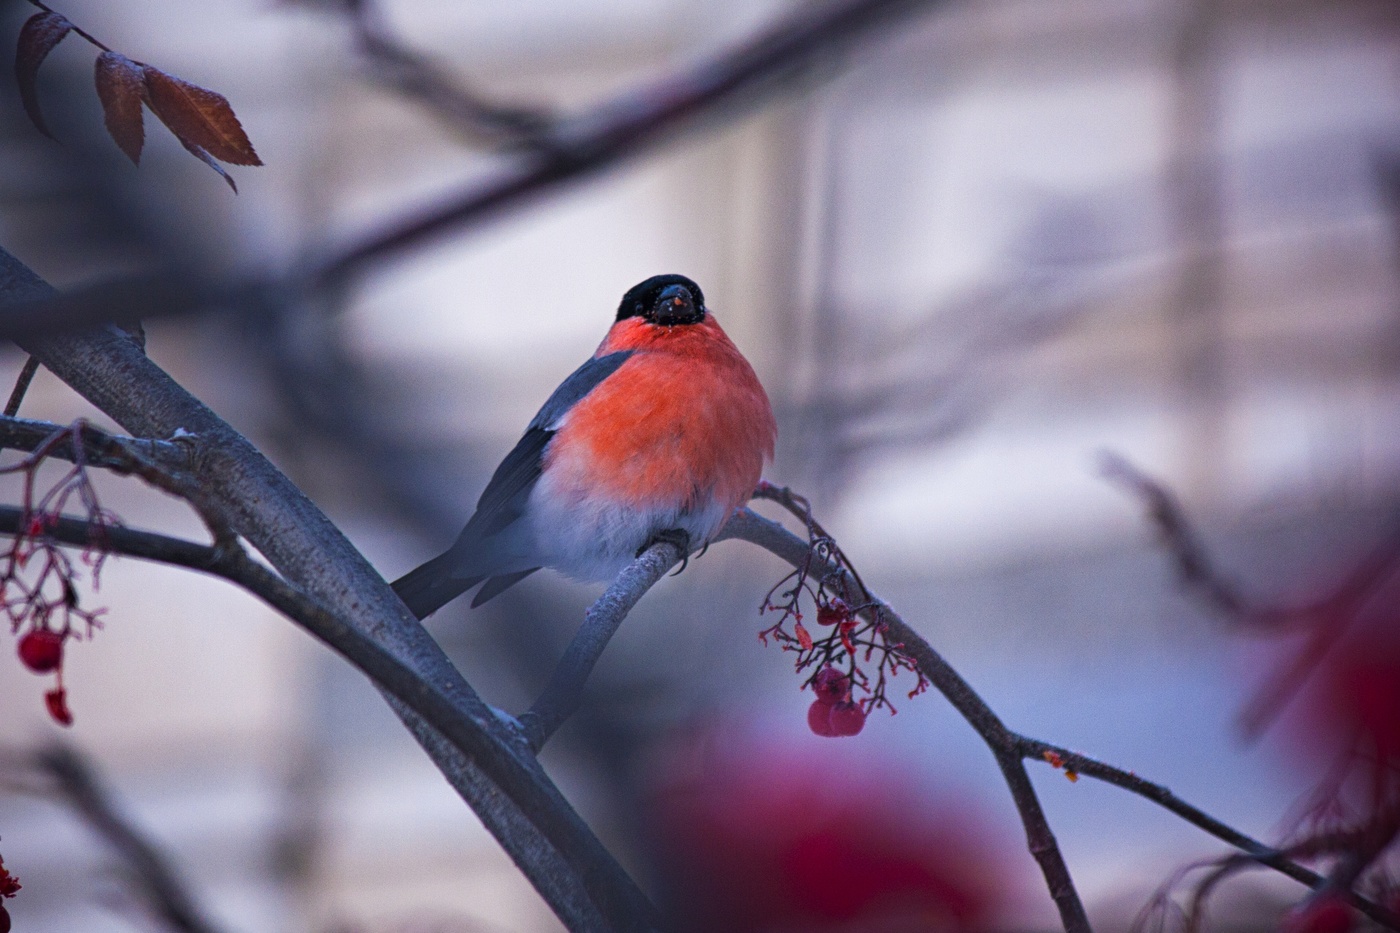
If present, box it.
[519,541,682,752]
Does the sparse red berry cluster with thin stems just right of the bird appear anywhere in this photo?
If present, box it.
[759,481,928,737]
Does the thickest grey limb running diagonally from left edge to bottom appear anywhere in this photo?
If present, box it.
[0,251,655,930]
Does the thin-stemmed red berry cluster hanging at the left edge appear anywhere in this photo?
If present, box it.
[0,422,120,726]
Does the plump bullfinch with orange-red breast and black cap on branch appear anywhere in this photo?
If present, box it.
[391,275,777,619]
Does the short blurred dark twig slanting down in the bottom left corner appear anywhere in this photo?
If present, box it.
[35,745,220,933]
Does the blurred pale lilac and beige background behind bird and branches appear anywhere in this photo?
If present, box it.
[0,0,1400,933]
